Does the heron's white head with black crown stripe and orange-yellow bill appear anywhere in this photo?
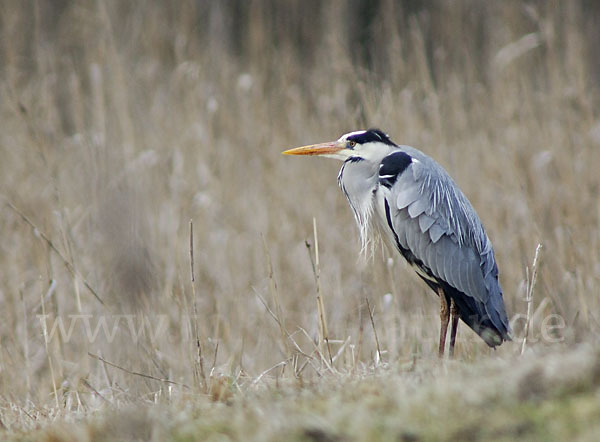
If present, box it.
[283,129,396,162]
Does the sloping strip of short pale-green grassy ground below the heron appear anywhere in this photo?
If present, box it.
[11,345,600,441]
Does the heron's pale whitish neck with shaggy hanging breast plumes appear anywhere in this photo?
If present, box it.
[338,158,379,249]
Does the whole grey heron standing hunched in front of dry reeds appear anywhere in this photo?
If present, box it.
[283,129,511,357]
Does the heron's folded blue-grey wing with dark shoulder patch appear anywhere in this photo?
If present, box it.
[382,148,508,335]
